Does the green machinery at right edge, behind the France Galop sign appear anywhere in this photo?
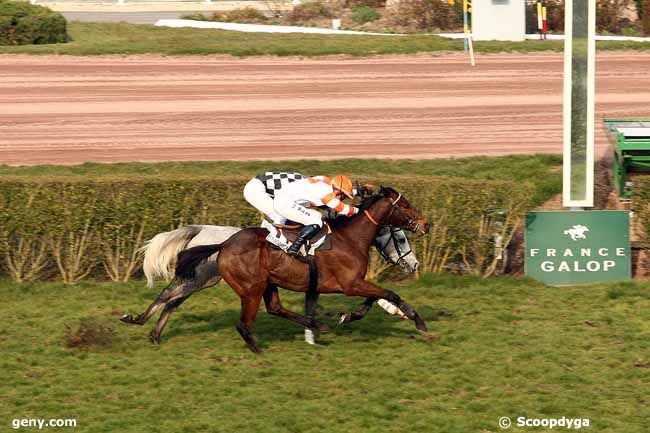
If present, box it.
[604,119,650,200]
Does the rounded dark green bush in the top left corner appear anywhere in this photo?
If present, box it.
[0,0,68,45]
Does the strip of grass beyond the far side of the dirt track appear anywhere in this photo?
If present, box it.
[0,22,650,56]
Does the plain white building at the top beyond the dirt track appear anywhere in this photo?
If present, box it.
[472,0,526,41]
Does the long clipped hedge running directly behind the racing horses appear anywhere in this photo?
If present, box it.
[0,176,533,283]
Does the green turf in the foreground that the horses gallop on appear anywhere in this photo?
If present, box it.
[0,276,650,433]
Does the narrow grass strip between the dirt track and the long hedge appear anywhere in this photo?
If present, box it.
[0,155,562,207]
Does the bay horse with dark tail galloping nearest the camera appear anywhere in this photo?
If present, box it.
[176,187,429,353]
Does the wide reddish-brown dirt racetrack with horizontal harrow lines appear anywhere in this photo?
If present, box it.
[0,52,650,165]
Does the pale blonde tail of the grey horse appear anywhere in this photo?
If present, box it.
[140,225,203,287]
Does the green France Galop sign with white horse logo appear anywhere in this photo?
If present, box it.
[525,211,631,285]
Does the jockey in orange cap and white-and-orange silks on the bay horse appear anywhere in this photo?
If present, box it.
[273,175,359,256]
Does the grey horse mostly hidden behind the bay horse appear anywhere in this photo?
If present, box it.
[120,225,420,344]
